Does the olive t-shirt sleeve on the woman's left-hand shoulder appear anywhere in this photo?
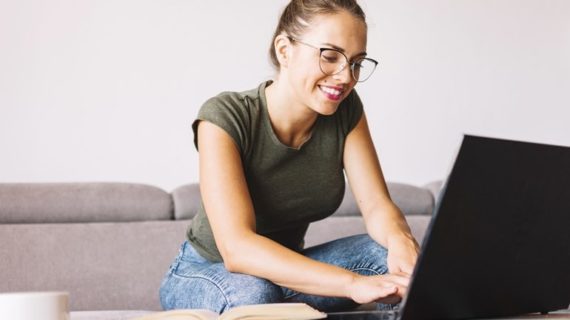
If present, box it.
[192,93,248,155]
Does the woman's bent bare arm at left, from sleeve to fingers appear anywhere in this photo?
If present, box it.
[198,121,404,303]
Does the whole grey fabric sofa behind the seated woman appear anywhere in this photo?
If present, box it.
[0,182,441,320]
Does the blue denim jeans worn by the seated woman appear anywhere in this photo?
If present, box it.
[160,235,388,313]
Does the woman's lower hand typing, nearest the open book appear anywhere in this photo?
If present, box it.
[349,273,410,304]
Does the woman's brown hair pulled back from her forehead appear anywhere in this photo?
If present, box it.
[269,0,366,70]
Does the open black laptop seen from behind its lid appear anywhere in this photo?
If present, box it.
[328,135,570,320]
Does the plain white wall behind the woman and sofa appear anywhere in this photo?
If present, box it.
[0,0,570,190]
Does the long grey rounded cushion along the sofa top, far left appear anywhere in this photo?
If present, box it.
[0,183,173,223]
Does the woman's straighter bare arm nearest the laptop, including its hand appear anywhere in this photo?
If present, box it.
[344,115,419,274]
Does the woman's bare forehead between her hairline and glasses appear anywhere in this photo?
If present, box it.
[303,11,367,54]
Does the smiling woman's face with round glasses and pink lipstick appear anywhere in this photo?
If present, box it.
[288,11,366,115]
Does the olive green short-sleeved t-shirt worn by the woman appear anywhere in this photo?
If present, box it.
[187,81,363,262]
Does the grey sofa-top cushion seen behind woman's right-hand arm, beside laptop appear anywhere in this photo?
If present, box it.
[334,182,435,216]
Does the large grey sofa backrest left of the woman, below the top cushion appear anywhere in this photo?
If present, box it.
[0,220,189,310]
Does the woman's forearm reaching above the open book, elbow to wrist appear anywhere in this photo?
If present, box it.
[224,234,357,298]
